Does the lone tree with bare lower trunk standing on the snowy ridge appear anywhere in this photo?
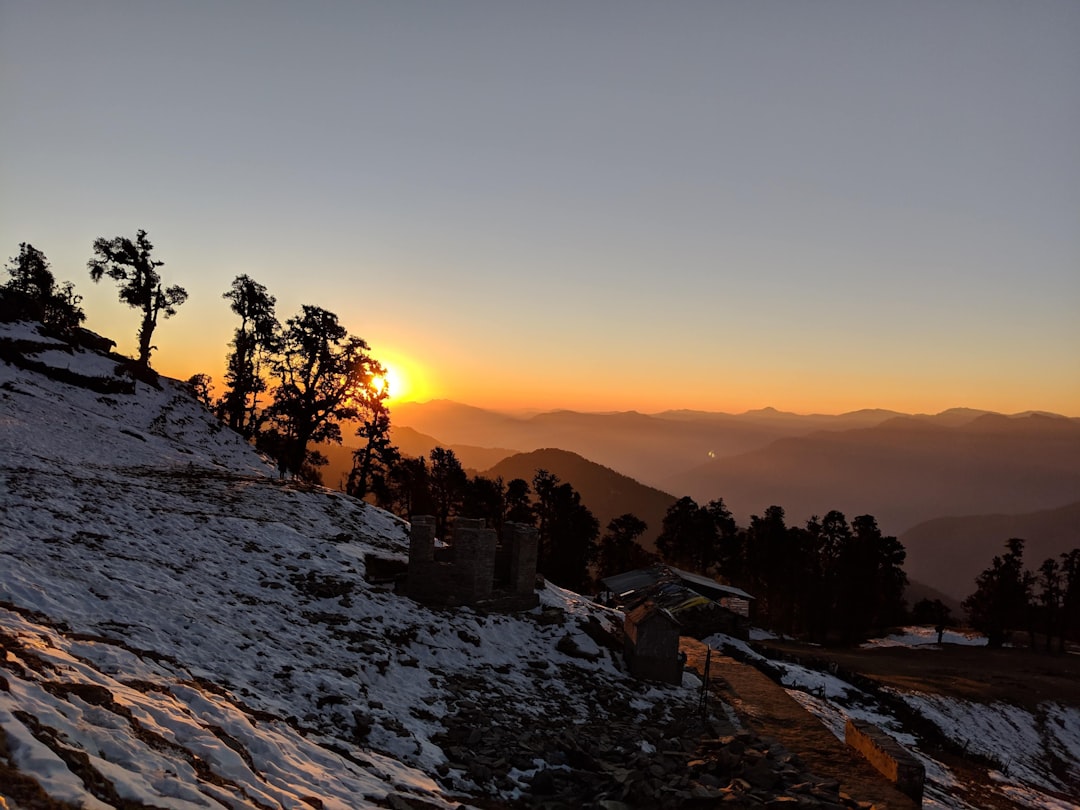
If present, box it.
[86,230,188,367]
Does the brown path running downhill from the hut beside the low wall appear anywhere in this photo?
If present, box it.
[680,637,918,810]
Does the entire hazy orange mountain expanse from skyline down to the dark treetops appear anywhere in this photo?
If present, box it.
[362,401,1080,598]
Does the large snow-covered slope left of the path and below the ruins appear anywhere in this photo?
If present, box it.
[0,324,697,808]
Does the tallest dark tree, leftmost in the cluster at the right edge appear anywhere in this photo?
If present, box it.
[962,537,1035,647]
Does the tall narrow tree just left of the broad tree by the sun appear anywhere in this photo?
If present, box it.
[220,275,281,438]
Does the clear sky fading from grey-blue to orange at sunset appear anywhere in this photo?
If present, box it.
[0,0,1080,416]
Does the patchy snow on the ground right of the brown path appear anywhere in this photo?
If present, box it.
[705,627,1080,810]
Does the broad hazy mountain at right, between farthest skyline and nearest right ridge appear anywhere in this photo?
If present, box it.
[664,414,1080,534]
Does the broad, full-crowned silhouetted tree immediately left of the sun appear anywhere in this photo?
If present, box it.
[267,305,383,473]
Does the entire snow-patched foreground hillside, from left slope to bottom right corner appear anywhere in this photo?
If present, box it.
[0,324,1080,810]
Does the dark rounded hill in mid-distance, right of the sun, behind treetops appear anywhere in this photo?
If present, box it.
[484,448,675,550]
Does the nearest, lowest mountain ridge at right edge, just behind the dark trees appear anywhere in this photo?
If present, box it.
[900,501,1080,599]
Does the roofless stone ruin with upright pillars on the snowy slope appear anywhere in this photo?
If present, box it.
[405,515,540,610]
